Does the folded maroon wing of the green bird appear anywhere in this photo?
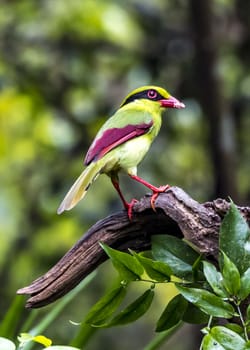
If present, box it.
[84,121,153,165]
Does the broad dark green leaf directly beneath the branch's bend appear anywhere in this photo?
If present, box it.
[152,235,199,278]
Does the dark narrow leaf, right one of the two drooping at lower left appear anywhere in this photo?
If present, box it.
[101,288,154,327]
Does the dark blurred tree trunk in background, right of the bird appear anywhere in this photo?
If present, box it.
[189,0,239,201]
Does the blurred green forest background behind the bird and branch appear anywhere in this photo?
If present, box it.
[0,0,250,350]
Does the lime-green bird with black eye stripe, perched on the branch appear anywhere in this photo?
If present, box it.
[57,86,185,219]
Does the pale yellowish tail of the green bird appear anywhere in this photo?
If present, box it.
[57,160,105,214]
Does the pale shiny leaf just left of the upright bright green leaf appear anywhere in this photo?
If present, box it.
[203,261,227,298]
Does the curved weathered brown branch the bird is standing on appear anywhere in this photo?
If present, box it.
[17,187,250,308]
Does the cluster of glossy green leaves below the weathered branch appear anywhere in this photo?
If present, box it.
[85,203,250,350]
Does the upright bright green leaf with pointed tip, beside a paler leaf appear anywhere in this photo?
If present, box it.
[222,252,240,296]
